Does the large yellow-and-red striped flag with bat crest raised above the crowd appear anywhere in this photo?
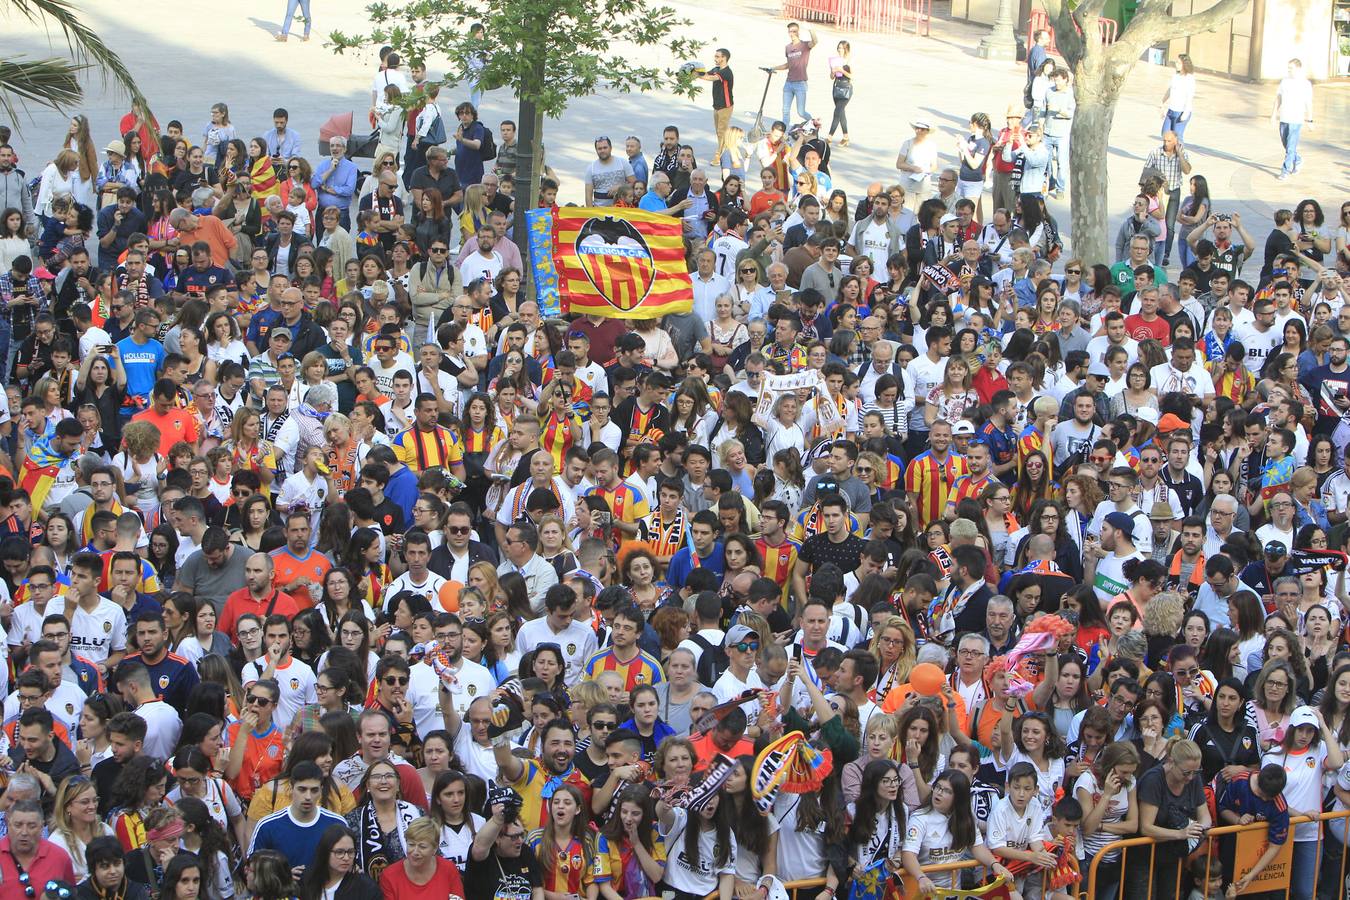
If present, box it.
[554,206,694,318]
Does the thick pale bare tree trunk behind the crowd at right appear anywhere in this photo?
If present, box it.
[1069,53,1121,264]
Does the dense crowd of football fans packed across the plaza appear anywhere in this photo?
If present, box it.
[0,15,1350,900]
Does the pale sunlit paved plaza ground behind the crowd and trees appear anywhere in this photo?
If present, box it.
[0,0,1350,256]
